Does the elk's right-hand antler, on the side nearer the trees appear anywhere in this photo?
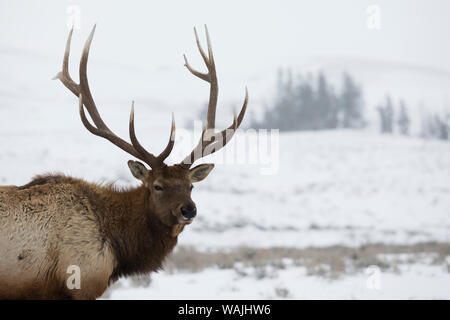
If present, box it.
[180,25,248,168]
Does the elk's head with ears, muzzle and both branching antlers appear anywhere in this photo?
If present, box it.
[55,26,248,226]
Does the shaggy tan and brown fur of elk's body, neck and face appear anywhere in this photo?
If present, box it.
[0,162,211,299]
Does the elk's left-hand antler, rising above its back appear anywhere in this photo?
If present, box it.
[55,25,175,169]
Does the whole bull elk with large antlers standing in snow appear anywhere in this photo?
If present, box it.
[0,26,248,299]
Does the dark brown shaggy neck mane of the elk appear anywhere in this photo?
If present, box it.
[88,186,178,281]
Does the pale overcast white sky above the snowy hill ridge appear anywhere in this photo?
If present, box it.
[0,0,450,70]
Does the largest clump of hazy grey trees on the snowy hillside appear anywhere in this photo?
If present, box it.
[251,70,366,131]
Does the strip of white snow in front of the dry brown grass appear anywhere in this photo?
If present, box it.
[109,265,450,300]
